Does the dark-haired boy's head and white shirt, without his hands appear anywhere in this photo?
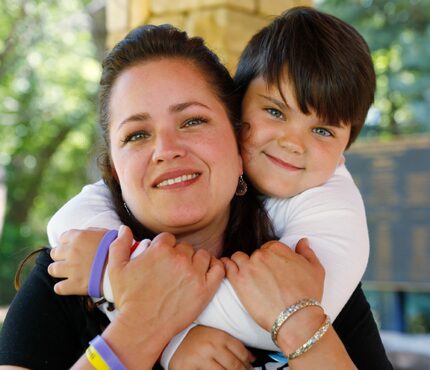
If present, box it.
[48,8,375,368]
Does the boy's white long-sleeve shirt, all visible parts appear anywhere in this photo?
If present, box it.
[48,165,369,368]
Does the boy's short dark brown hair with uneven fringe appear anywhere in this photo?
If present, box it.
[234,7,376,148]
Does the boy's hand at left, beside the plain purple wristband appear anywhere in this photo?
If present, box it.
[48,228,108,295]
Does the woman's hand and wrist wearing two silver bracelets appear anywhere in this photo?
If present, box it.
[223,239,324,355]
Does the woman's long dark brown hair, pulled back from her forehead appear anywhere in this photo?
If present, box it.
[99,25,273,255]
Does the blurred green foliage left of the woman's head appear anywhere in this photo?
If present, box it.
[0,0,100,304]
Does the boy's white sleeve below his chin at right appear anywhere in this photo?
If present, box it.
[267,166,369,320]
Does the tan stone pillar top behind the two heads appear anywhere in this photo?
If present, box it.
[106,0,313,71]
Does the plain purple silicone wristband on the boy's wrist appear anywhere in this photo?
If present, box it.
[88,230,118,298]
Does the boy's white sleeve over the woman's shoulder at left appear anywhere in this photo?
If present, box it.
[47,181,121,247]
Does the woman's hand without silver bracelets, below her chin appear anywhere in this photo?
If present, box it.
[107,226,225,343]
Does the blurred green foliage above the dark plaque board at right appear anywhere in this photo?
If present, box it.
[317,0,430,136]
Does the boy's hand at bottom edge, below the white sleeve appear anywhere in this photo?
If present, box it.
[169,326,254,370]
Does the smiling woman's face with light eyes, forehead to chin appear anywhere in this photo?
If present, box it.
[109,59,242,234]
